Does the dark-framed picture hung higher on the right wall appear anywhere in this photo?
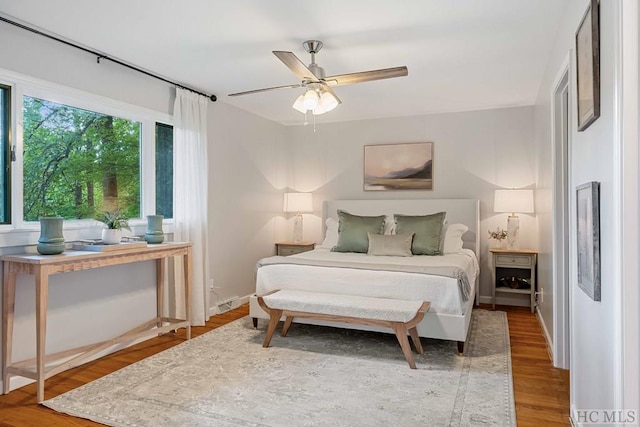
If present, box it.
[576,0,600,132]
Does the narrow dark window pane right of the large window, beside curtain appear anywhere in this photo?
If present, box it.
[156,123,173,218]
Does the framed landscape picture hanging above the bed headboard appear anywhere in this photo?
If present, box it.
[363,142,433,191]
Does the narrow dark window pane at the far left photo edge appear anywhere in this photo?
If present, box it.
[0,85,11,224]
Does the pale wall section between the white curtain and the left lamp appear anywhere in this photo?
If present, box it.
[209,103,287,306]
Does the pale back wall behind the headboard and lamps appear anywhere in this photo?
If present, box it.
[288,107,537,304]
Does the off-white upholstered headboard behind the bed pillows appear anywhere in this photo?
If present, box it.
[322,199,480,259]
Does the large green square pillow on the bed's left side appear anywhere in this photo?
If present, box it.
[331,209,385,253]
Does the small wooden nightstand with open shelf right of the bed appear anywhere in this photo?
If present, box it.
[490,249,538,313]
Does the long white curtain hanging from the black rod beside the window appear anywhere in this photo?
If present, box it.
[170,88,209,326]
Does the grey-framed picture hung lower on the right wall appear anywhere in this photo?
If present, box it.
[576,182,601,301]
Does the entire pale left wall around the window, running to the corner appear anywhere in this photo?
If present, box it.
[0,18,284,392]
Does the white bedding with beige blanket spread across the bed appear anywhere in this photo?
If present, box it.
[256,249,479,315]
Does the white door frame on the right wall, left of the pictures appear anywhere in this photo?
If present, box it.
[547,50,572,369]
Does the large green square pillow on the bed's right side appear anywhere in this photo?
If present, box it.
[393,212,447,255]
